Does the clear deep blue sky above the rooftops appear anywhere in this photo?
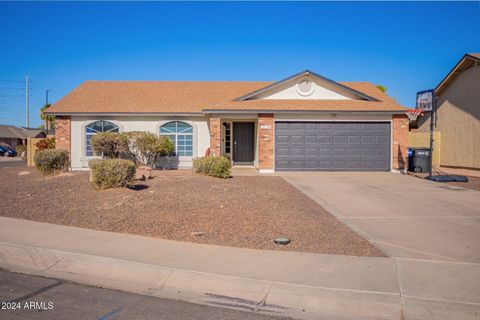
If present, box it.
[0,2,480,126]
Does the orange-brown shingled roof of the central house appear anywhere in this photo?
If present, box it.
[48,81,406,114]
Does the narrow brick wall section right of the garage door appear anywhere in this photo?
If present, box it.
[392,115,408,170]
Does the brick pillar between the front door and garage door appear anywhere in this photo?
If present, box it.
[258,114,275,170]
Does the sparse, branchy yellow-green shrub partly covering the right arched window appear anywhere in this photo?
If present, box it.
[120,131,174,166]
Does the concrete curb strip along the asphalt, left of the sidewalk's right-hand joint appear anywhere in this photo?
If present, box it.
[0,242,401,319]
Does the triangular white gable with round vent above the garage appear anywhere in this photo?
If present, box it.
[235,70,379,101]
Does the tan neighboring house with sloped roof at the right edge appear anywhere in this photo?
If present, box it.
[412,53,480,170]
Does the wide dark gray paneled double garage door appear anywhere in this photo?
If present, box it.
[275,122,390,171]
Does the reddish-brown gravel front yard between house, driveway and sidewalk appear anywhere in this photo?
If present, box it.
[0,168,383,256]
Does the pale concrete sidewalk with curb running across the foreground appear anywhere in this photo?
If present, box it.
[0,217,480,319]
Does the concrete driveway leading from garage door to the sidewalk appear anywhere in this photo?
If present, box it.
[281,172,480,263]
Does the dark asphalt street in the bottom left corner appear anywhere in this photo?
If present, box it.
[0,269,285,320]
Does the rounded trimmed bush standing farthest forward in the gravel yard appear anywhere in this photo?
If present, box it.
[88,159,135,190]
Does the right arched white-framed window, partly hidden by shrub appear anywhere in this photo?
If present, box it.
[160,121,193,157]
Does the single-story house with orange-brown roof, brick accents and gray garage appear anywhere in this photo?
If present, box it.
[48,70,408,173]
